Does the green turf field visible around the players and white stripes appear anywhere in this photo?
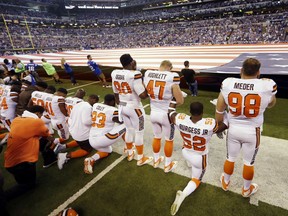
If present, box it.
[0,80,288,216]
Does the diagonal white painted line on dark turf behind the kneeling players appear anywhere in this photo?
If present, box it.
[48,155,125,216]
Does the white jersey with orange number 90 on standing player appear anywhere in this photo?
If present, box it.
[111,69,145,107]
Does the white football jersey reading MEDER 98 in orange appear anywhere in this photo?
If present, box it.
[221,78,277,127]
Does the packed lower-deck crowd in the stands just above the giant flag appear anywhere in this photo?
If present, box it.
[0,12,288,55]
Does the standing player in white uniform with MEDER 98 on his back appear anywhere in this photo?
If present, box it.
[215,58,277,197]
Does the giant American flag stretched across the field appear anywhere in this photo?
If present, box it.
[0,44,288,75]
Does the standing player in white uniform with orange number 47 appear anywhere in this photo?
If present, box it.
[144,60,184,173]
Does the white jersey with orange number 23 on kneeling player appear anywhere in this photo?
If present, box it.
[90,103,118,137]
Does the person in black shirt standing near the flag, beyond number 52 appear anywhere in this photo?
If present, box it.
[181,61,198,96]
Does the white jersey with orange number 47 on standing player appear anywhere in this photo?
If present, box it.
[144,70,180,112]
